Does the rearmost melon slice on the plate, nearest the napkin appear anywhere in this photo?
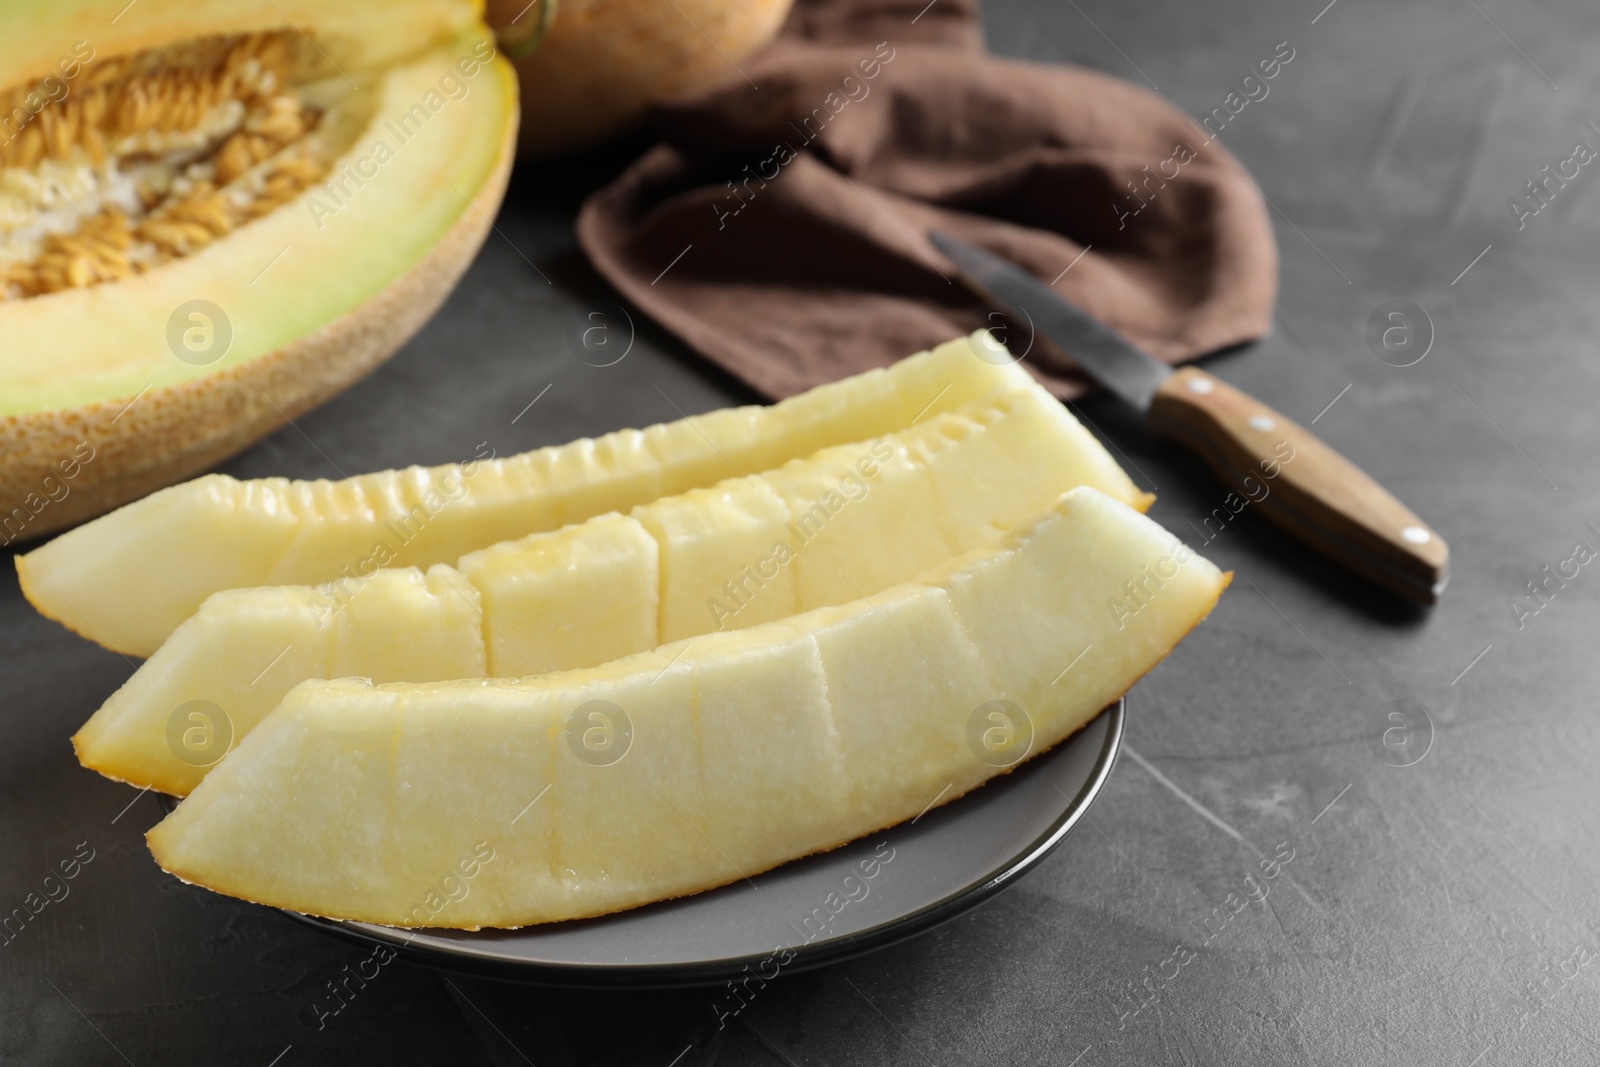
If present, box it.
[25,334,1056,656]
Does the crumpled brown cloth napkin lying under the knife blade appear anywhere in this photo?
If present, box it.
[578,0,1277,397]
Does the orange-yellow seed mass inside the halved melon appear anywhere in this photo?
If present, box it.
[0,34,328,301]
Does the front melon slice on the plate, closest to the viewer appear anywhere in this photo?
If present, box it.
[149,486,1227,929]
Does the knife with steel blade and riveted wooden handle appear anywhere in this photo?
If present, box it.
[930,234,1450,603]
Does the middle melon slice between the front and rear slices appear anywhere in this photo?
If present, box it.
[74,384,1146,795]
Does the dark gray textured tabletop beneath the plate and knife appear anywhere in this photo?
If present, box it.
[0,0,1600,1067]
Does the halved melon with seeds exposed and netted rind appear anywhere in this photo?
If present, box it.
[0,0,517,544]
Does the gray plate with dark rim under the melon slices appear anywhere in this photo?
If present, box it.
[246,701,1125,989]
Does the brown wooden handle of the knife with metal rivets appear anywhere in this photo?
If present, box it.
[1149,366,1450,603]
